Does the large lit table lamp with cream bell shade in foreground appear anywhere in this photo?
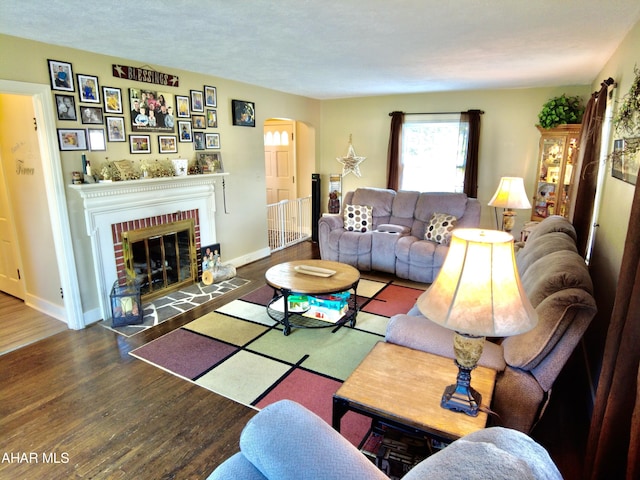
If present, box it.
[417,228,538,417]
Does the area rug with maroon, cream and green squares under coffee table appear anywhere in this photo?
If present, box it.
[131,279,423,445]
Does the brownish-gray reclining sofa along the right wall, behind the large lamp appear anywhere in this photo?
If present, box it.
[386,216,596,433]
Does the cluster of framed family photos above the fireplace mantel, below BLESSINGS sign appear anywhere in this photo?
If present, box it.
[47,59,225,164]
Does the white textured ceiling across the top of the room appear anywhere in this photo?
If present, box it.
[0,0,640,99]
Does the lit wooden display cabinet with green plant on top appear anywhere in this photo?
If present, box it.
[531,124,581,221]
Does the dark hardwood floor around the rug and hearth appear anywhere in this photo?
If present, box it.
[0,242,588,480]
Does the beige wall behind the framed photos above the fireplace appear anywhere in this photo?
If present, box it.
[0,35,320,318]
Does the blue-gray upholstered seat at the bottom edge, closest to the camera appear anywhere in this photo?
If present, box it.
[209,400,562,480]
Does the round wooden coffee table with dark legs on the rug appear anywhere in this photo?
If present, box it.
[265,260,360,335]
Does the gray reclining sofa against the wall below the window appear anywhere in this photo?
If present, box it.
[318,188,480,283]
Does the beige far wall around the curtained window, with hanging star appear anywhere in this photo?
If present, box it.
[319,86,590,236]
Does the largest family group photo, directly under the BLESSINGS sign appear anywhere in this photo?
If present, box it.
[129,88,175,133]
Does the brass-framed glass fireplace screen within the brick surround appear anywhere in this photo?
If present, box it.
[122,220,198,299]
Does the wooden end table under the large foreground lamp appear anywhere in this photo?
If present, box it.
[333,342,496,443]
